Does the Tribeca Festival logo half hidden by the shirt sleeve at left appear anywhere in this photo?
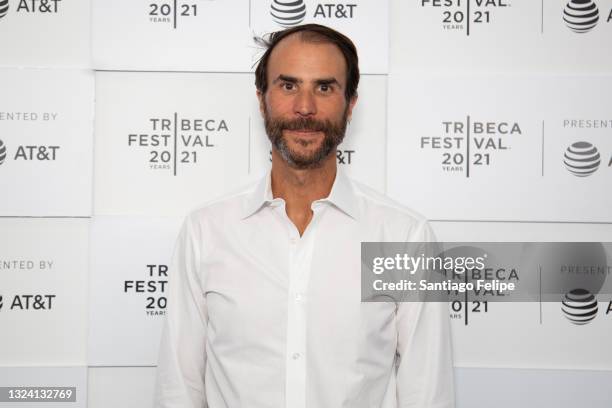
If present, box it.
[123,264,168,316]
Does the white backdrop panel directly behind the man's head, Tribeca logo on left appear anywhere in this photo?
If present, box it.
[94,72,387,216]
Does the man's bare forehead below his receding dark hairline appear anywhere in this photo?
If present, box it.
[268,33,346,84]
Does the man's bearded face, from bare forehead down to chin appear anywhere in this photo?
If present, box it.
[258,34,356,169]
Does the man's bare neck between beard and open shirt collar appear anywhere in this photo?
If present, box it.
[272,149,337,235]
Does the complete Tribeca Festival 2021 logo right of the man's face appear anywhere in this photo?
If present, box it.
[420,116,523,177]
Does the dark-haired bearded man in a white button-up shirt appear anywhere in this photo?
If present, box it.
[156,24,454,408]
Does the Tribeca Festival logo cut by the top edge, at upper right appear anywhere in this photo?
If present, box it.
[421,0,511,36]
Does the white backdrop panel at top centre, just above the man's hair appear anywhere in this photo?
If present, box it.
[92,0,389,74]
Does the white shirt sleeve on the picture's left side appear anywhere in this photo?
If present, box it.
[154,218,208,408]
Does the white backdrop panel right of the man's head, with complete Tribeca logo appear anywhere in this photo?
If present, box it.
[387,75,612,222]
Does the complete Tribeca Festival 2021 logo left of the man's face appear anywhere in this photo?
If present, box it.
[127,112,229,176]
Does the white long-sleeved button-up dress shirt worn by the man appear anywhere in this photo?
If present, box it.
[155,170,454,408]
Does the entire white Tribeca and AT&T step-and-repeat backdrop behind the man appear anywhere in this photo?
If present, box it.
[0,0,612,406]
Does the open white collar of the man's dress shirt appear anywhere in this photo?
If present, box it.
[242,168,357,219]
